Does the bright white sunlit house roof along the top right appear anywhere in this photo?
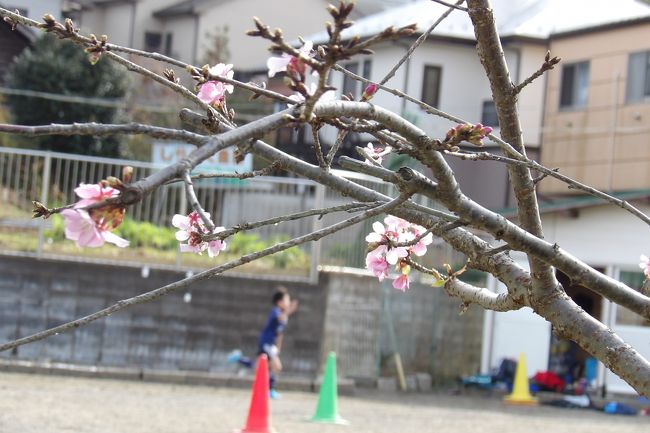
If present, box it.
[307,0,650,43]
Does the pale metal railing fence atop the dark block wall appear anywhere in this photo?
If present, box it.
[0,147,446,281]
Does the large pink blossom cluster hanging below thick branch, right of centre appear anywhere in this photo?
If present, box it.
[366,215,433,291]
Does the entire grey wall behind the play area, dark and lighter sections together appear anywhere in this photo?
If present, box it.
[0,256,482,382]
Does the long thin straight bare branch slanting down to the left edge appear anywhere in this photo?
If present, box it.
[0,194,409,352]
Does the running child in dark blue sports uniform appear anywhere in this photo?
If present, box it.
[258,287,298,398]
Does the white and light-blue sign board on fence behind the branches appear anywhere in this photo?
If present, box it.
[151,141,253,183]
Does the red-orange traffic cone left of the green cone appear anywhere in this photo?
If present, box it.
[236,354,275,433]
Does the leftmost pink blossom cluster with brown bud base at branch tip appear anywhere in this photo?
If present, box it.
[61,183,129,248]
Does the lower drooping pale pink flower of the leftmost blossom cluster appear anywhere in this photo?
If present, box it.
[61,209,129,248]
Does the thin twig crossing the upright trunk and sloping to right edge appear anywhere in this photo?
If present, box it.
[445,152,650,225]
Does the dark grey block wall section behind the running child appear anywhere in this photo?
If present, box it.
[0,257,326,374]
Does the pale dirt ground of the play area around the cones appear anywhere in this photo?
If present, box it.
[0,373,650,433]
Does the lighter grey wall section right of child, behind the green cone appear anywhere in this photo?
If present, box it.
[322,273,483,383]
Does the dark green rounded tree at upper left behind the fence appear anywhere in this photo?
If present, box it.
[5,35,128,157]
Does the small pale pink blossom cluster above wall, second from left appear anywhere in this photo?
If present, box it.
[172,212,226,257]
